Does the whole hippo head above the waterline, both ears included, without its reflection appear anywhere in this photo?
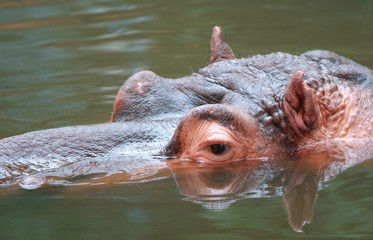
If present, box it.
[0,27,373,179]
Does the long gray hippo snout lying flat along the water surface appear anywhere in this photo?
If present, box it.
[0,119,178,179]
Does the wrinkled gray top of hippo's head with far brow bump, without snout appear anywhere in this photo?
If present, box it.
[113,50,373,150]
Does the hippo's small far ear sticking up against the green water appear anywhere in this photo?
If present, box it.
[210,26,236,63]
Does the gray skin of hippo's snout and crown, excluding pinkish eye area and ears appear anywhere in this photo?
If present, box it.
[0,38,373,179]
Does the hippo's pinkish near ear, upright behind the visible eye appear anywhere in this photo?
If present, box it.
[283,71,318,137]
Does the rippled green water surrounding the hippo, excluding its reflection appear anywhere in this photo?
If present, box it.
[0,0,373,239]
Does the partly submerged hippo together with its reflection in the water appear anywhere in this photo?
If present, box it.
[0,27,373,231]
